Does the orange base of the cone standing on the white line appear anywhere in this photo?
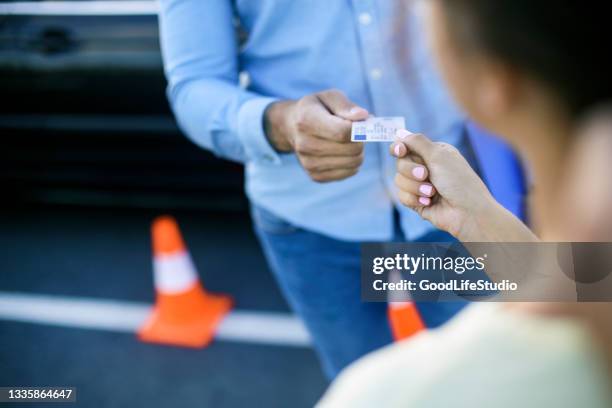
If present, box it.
[138,294,233,348]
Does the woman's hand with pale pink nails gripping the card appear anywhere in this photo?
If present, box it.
[391,130,535,241]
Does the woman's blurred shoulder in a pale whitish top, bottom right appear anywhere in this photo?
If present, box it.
[320,303,610,407]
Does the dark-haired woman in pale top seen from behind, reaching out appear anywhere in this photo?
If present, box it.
[320,0,612,407]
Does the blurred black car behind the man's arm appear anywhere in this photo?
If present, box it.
[0,1,245,209]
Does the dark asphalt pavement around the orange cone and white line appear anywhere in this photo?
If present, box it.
[0,207,327,408]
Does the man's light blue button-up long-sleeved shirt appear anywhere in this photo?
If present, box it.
[160,0,463,241]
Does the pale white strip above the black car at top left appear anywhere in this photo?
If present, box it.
[0,0,159,16]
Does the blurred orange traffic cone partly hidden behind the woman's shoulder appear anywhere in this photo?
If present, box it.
[387,270,425,341]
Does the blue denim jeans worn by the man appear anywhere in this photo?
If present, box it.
[251,206,465,379]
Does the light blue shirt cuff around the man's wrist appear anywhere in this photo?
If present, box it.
[238,97,281,164]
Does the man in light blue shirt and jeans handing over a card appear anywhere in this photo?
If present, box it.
[160,0,464,377]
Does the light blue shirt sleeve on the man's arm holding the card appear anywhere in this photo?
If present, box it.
[159,0,280,164]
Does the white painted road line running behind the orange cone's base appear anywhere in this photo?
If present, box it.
[0,292,310,347]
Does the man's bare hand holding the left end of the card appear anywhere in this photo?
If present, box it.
[265,90,368,183]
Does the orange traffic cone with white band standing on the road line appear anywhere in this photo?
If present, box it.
[138,216,233,347]
